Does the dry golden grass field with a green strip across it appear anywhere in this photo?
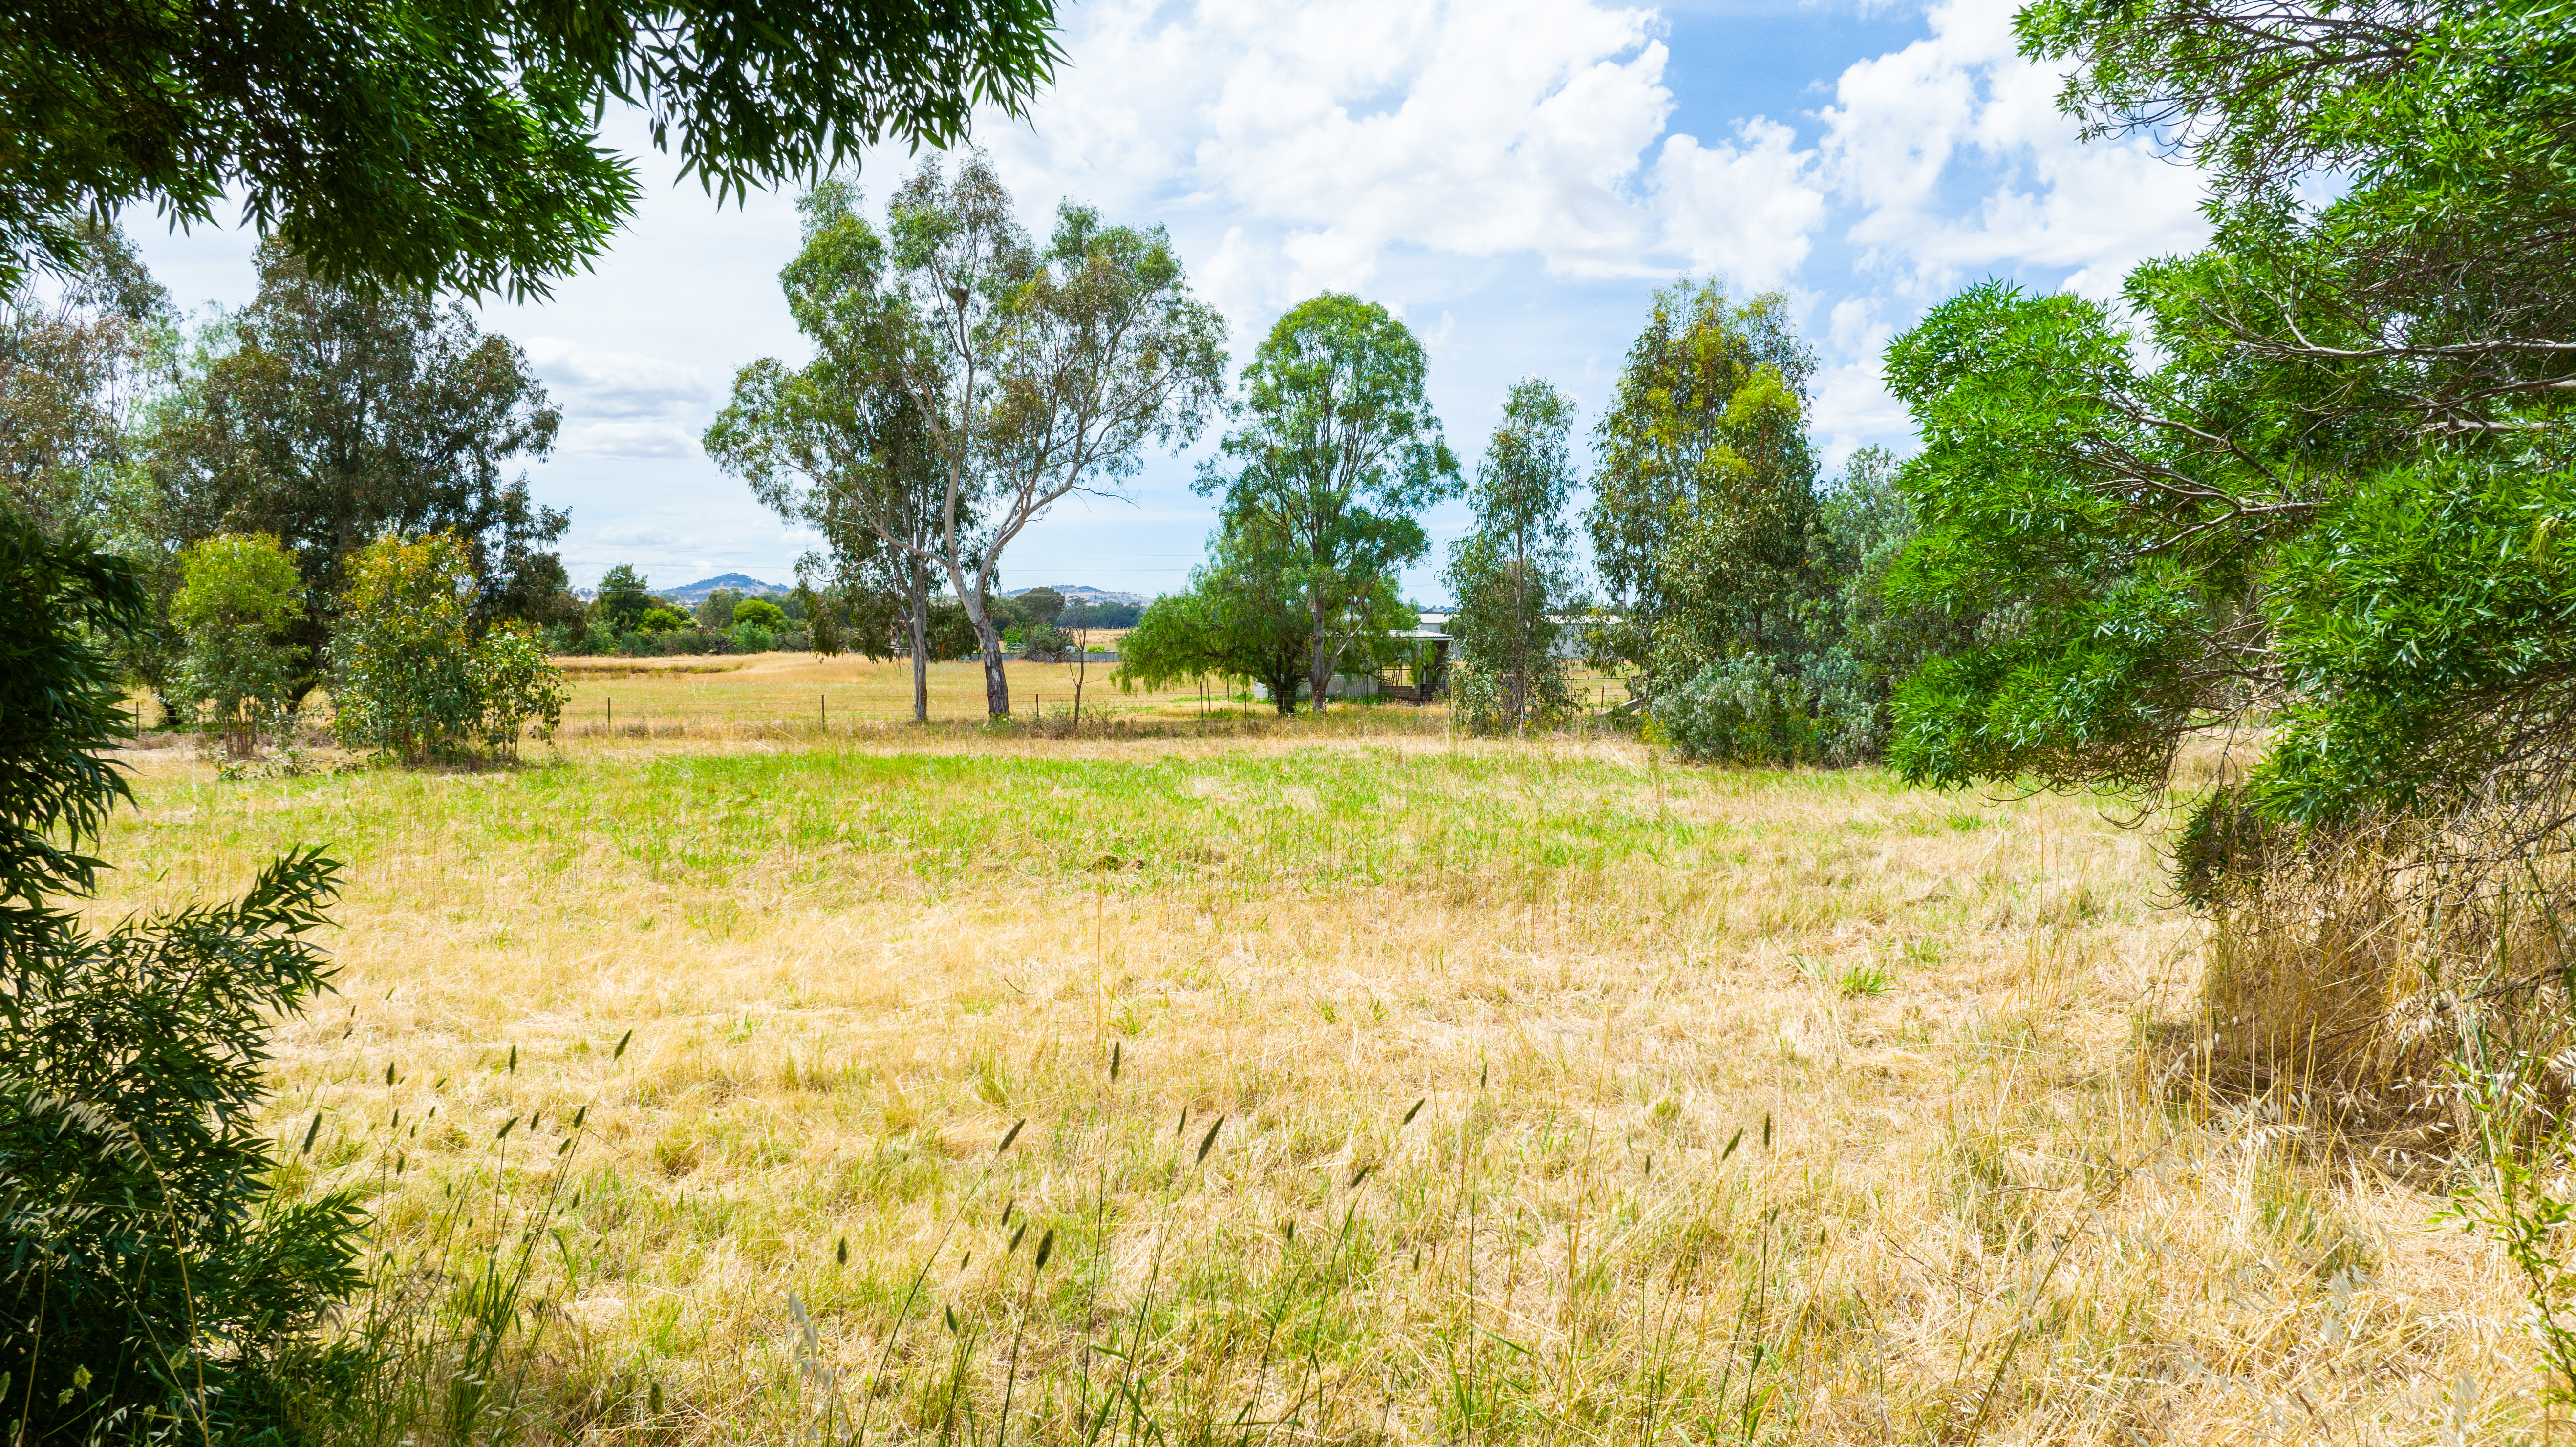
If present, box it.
[101,716,2540,1445]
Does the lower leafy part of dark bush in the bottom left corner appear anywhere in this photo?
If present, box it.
[0,852,366,1442]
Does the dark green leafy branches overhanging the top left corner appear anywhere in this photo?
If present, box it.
[0,0,1059,298]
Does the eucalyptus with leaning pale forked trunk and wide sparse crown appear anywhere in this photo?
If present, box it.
[871,154,1226,718]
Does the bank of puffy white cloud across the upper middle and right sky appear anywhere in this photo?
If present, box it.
[963,0,2200,450]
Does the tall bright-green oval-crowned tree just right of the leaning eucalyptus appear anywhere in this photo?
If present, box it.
[1195,291,1458,708]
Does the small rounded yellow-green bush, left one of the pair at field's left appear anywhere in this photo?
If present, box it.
[170,533,304,760]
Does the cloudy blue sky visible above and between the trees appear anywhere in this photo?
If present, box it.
[136,0,2203,600]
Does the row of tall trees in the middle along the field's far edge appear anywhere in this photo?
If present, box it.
[706,154,1924,741]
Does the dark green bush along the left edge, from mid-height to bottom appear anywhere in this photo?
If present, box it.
[0,499,366,1442]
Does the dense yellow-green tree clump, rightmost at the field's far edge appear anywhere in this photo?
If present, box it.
[1587,283,1942,765]
